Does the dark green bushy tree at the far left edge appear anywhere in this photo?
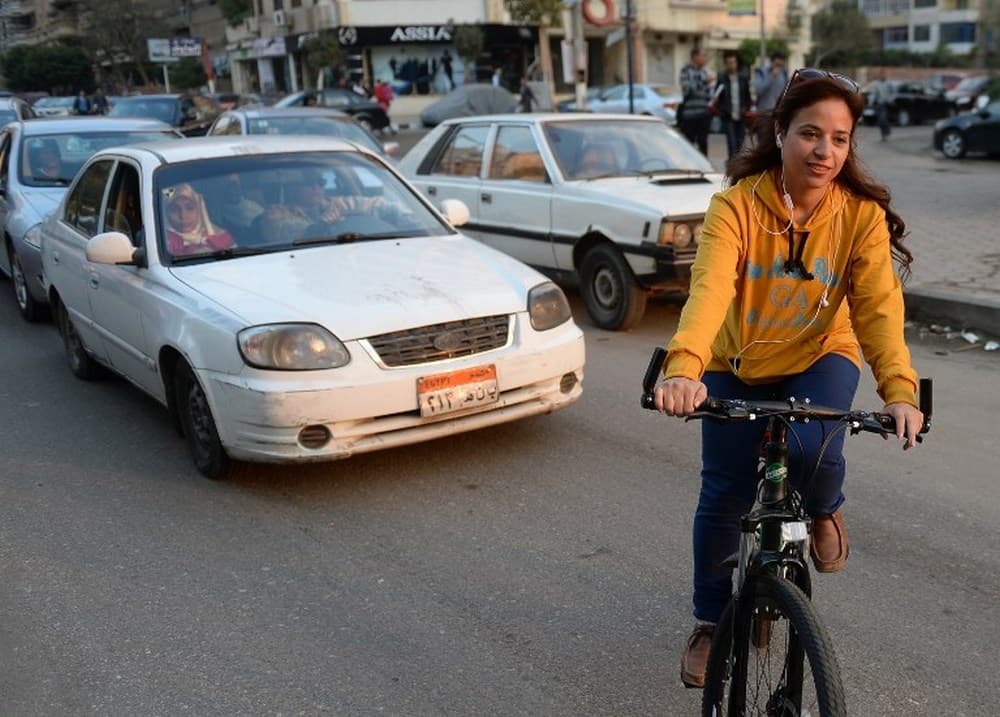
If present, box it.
[0,44,94,92]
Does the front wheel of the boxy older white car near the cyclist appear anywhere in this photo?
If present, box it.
[580,244,646,331]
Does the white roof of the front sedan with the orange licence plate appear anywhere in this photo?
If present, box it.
[93,134,374,164]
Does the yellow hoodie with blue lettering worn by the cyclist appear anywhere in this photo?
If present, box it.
[664,165,917,405]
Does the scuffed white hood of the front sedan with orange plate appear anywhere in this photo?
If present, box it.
[170,235,545,341]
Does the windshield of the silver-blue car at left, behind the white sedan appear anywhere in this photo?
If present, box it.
[18,130,177,187]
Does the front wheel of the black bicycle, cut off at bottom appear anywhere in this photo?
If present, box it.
[702,575,847,717]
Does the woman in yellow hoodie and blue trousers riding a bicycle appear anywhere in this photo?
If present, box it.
[655,69,923,687]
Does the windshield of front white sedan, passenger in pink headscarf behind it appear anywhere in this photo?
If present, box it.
[154,151,453,264]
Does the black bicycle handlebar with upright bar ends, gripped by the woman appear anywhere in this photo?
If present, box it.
[641,346,934,442]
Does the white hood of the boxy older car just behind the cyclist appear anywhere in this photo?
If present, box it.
[573,172,722,216]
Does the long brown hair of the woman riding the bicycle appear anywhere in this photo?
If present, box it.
[726,76,913,279]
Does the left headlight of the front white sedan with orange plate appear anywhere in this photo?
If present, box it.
[236,324,351,371]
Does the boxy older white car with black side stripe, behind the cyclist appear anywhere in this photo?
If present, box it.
[399,113,722,330]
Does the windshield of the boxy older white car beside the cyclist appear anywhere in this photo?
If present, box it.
[544,119,714,180]
